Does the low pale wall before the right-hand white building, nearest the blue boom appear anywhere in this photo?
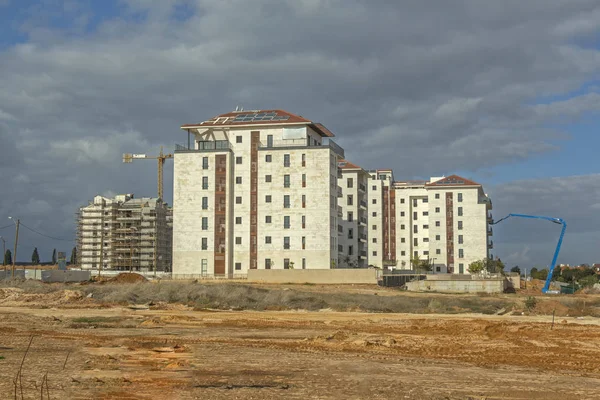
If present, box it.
[406,279,504,293]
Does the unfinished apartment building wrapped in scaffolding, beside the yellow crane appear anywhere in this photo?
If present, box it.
[77,194,173,271]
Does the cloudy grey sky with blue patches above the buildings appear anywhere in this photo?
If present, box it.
[0,0,600,266]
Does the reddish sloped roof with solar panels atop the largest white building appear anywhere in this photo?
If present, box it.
[181,110,335,137]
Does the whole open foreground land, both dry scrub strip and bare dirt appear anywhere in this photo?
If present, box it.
[0,274,600,400]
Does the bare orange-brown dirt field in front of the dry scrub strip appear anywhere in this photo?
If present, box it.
[0,287,600,400]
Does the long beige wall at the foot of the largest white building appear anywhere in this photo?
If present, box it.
[248,269,378,285]
